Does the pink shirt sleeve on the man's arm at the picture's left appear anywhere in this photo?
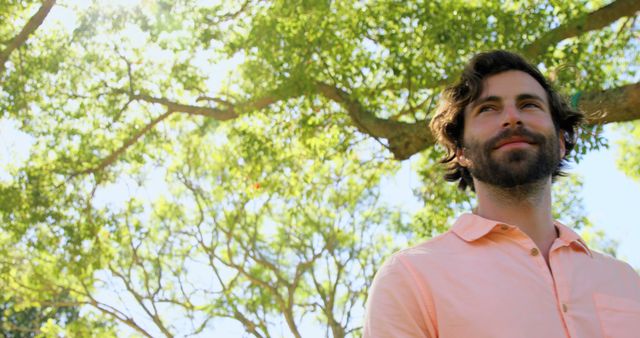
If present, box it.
[363,256,436,338]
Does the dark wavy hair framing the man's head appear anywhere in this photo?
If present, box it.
[429,50,584,191]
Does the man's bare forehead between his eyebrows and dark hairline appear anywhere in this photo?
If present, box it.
[476,70,547,103]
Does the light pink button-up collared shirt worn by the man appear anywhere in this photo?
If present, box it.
[364,214,640,338]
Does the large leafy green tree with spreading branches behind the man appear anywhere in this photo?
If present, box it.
[0,0,640,337]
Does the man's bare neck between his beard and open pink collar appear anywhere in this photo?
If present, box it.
[474,178,557,258]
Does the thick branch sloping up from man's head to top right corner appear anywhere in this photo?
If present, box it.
[522,0,640,58]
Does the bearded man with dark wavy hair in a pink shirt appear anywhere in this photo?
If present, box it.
[364,51,640,338]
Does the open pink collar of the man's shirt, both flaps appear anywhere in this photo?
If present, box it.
[451,213,593,257]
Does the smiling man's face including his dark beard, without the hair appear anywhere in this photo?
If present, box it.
[458,71,564,188]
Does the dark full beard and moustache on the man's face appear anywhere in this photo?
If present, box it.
[464,128,561,188]
